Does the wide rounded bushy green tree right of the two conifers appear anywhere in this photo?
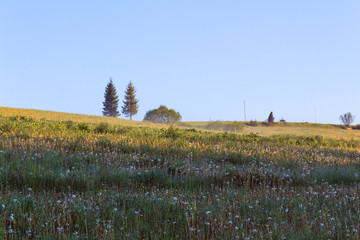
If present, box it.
[144,105,181,123]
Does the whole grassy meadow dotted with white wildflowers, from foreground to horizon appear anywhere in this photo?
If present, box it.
[0,108,360,239]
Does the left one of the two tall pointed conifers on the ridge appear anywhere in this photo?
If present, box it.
[103,78,120,117]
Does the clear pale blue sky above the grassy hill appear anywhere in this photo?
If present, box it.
[0,0,360,123]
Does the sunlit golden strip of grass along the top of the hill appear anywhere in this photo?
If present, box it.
[0,107,360,139]
